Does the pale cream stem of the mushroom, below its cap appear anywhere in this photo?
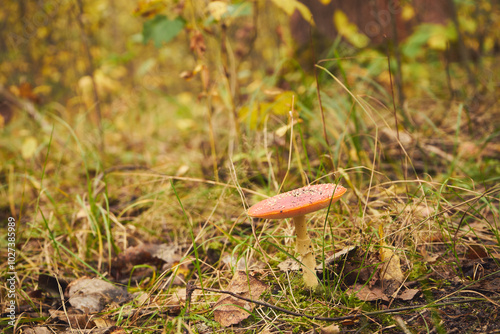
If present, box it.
[293,216,318,288]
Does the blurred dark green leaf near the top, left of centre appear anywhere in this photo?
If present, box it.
[142,15,186,48]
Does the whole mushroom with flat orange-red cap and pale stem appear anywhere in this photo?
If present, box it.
[248,183,347,288]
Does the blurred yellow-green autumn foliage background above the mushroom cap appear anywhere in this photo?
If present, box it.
[0,0,500,237]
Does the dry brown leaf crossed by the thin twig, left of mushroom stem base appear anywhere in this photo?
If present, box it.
[214,271,268,327]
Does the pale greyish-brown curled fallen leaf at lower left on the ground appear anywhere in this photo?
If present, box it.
[67,277,129,313]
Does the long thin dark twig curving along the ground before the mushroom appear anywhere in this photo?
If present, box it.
[194,286,500,321]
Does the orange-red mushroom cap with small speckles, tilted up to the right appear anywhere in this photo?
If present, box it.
[248,183,347,219]
